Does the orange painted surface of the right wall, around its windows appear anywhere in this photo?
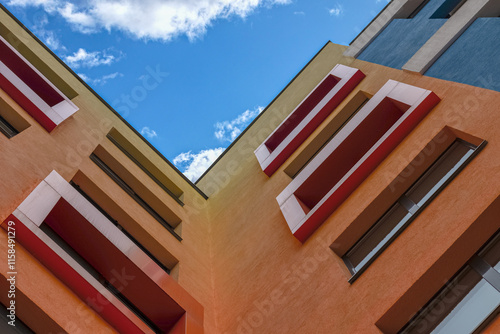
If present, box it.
[199,44,500,334]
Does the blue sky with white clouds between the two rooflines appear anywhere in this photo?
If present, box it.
[2,0,388,180]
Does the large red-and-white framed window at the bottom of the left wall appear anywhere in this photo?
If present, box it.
[8,171,203,333]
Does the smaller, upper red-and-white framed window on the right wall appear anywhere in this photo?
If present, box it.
[255,64,365,176]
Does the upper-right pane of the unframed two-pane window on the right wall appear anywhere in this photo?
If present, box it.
[406,141,474,206]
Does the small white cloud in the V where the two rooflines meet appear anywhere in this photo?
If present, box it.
[173,147,225,182]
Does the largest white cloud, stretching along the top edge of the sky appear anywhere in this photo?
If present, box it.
[7,0,291,41]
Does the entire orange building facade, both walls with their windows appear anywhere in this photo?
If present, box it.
[0,0,500,334]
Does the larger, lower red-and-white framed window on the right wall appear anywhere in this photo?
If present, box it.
[276,80,439,242]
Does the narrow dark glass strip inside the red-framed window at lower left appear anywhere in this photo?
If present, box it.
[40,223,163,334]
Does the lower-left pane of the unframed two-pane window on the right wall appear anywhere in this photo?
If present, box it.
[346,203,411,272]
